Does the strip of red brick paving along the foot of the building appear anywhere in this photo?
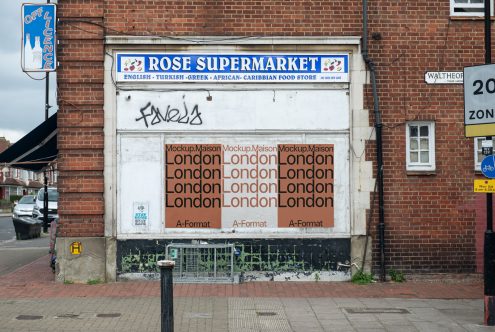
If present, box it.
[0,256,483,299]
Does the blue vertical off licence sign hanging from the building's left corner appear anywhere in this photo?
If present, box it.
[22,4,57,72]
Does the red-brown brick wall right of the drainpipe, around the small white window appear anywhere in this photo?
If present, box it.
[366,1,484,272]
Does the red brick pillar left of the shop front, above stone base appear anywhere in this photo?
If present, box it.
[57,0,105,236]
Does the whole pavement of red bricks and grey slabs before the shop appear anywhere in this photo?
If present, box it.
[0,256,495,332]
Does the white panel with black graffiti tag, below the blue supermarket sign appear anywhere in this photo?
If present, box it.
[117,89,349,132]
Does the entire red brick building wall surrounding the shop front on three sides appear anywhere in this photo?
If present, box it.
[58,0,484,272]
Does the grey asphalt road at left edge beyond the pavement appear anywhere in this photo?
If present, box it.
[0,217,50,276]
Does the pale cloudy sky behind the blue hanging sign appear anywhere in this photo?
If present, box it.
[0,0,57,143]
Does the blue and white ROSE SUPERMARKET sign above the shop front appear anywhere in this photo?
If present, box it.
[115,53,349,83]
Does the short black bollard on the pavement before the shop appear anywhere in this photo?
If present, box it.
[157,260,175,332]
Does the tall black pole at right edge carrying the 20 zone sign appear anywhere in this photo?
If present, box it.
[483,0,495,326]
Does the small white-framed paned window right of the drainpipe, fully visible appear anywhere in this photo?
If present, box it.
[406,121,435,171]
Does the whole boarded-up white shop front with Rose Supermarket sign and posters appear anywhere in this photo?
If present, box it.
[106,39,372,280]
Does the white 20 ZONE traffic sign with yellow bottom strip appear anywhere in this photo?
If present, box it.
[464,64,495,137]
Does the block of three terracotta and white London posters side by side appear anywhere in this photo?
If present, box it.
[165,144,334,228]
